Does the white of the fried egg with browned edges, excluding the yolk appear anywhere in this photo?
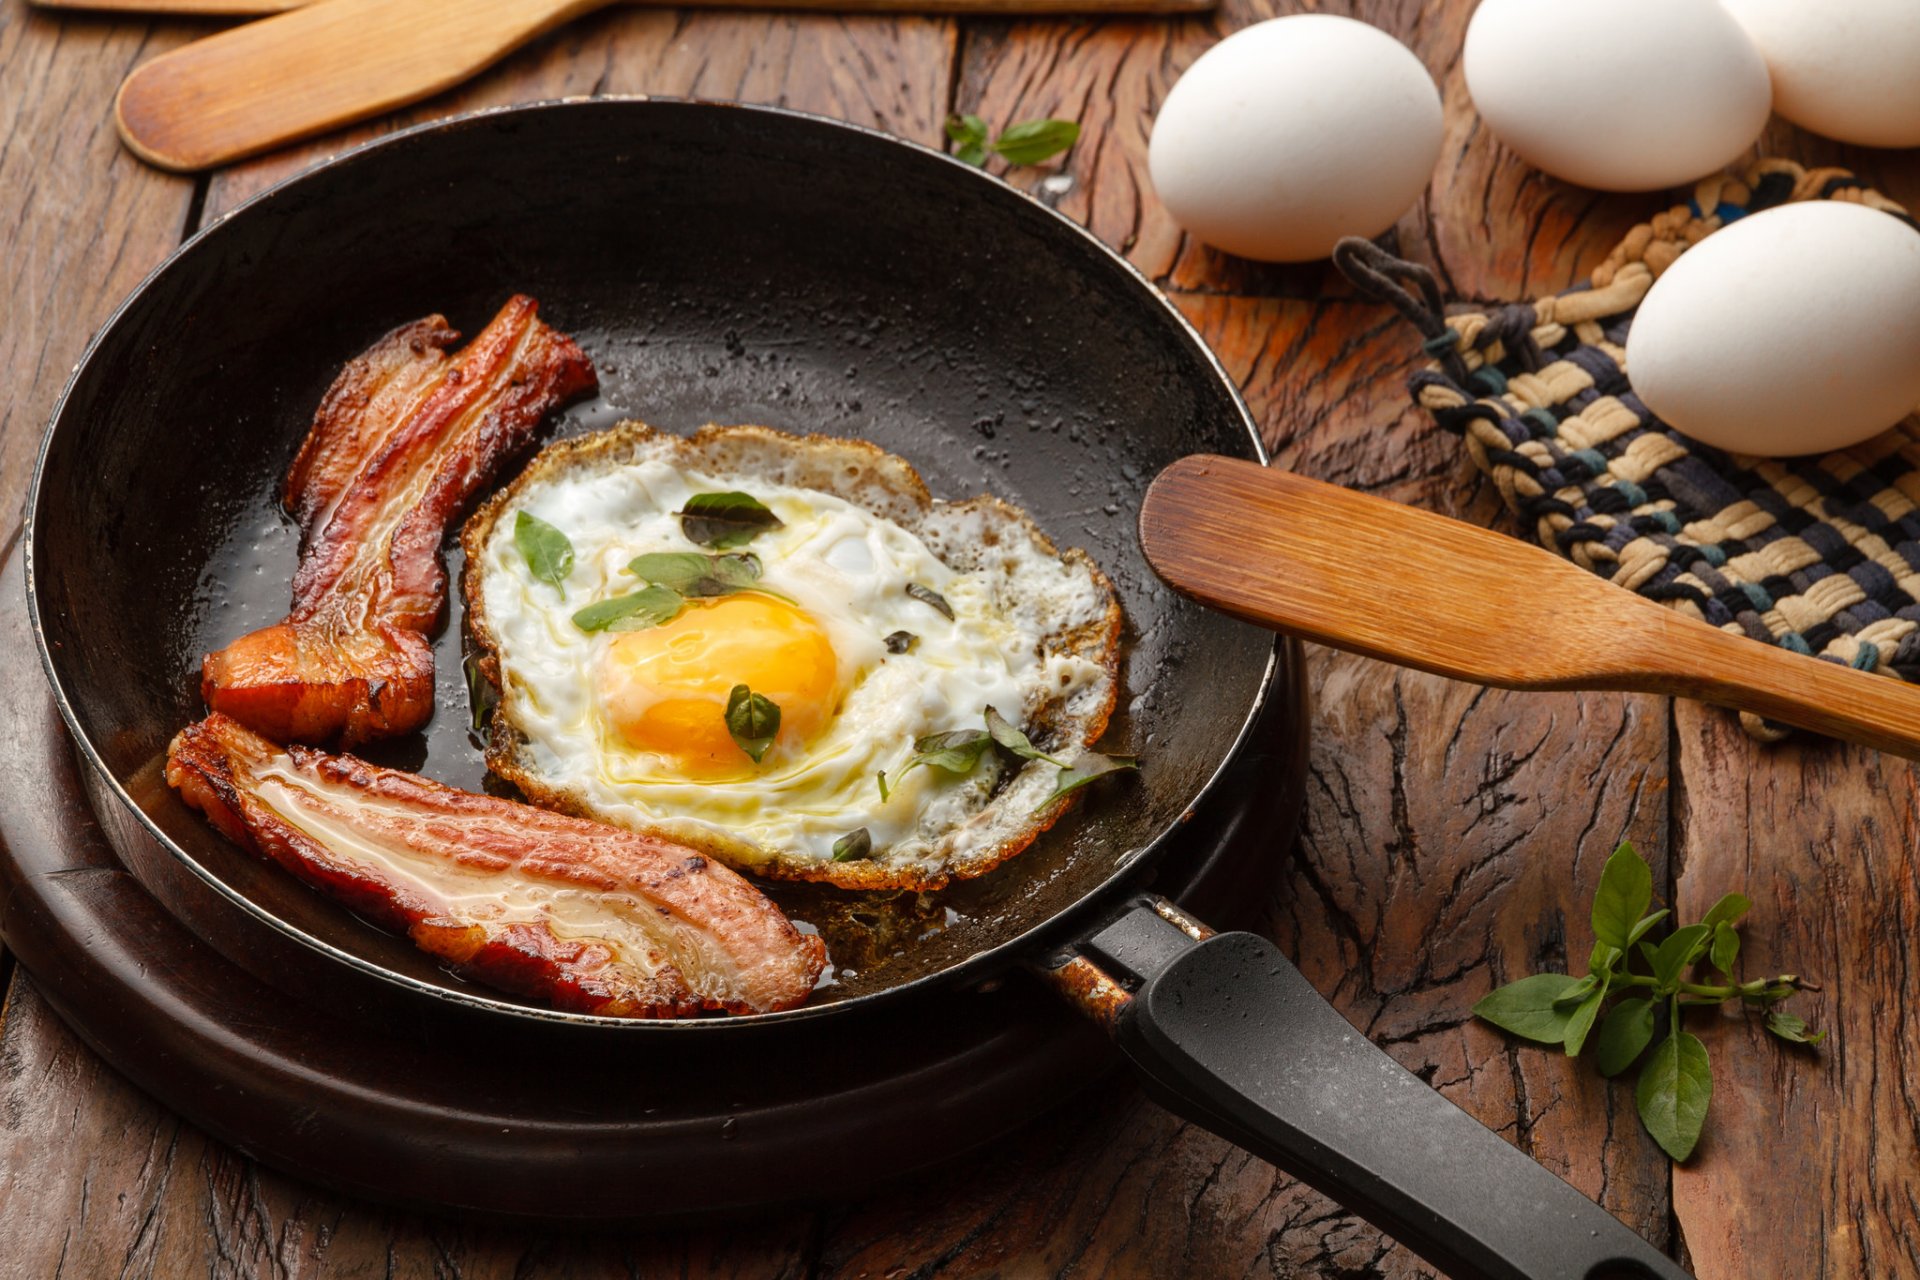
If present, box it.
[465,424,1117,885]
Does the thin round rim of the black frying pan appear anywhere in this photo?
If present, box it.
[19,94,1288,1034]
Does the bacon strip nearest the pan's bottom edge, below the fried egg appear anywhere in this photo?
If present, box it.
[167,712,826,1017]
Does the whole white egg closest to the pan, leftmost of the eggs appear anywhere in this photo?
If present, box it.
[1148,13,1442,263]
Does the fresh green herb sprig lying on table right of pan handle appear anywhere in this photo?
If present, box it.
[1473,842,1826,1161]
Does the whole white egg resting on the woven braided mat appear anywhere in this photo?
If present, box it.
[1626,201,1920,455]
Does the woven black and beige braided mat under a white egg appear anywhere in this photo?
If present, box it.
[1334,159,1920,741]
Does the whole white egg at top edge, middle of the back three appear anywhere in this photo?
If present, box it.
[1461,0,1772,192]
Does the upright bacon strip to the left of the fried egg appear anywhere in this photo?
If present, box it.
[200,296,595,747]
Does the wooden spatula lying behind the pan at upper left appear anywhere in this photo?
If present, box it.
[113,0,1213,173]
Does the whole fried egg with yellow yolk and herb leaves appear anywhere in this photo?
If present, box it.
[461,422,1119,889]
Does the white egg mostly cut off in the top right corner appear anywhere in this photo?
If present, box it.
[1724,0,1920,146]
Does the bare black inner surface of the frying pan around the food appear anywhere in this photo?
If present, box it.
[31,102,1273,1002]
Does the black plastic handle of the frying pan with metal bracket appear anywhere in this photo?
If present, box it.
[1056,898,1688,1280]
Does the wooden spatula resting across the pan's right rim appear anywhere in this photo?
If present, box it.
[1140,455,1920,758]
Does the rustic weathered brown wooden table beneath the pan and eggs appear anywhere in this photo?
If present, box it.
[0,0,1920,1280]
